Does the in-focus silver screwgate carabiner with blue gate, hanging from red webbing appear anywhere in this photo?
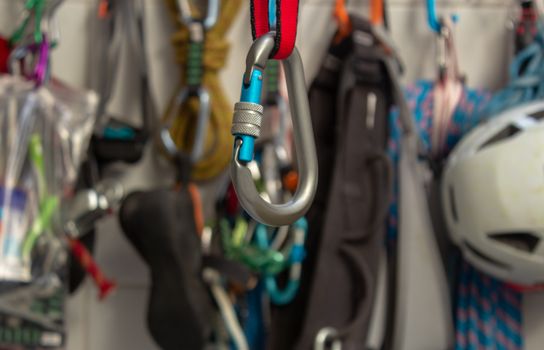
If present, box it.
[231,32,318,226]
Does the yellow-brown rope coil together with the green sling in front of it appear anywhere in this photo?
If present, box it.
[159,0,241,181]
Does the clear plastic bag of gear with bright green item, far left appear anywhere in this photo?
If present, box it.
[0,75,98,349]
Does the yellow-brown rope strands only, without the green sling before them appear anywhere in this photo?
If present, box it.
[165,0,241,181]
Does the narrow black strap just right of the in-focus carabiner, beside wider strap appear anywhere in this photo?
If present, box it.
[268,32,349,350]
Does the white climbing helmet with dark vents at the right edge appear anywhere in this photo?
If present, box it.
[441,102,544,286]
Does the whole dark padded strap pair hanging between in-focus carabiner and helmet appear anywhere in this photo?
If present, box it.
[271,17,394,350]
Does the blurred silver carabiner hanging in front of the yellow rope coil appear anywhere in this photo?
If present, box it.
[160,87,211,163]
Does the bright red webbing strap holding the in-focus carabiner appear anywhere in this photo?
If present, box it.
[251,0,299,60]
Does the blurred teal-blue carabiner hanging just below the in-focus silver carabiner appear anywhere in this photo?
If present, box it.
[255,218,308,305]
